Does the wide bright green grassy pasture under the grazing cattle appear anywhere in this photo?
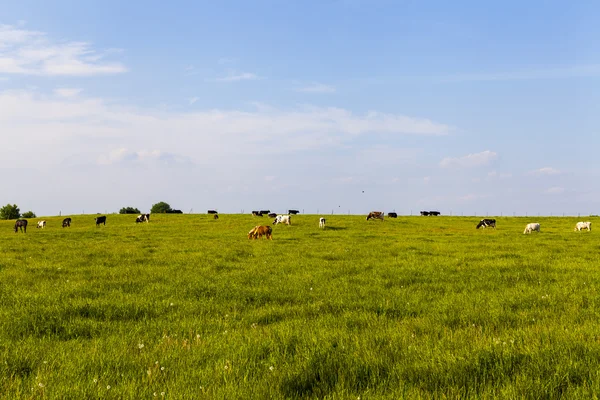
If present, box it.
[0,215,600,399]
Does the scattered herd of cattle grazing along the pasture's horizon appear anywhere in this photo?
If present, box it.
[9,210,592,240]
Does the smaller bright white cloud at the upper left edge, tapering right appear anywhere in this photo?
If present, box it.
[0,25,127,76]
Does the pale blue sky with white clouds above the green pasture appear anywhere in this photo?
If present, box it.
[0,0,600,215]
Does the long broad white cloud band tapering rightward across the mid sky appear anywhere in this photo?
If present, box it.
[0,91,450,167]
